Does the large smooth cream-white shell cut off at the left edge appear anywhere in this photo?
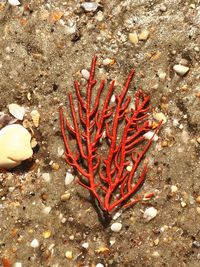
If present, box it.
[0,124,33,169]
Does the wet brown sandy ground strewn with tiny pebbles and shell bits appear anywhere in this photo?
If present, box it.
[0,0,200,267]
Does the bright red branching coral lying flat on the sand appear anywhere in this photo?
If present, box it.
[59,56,159,216]
